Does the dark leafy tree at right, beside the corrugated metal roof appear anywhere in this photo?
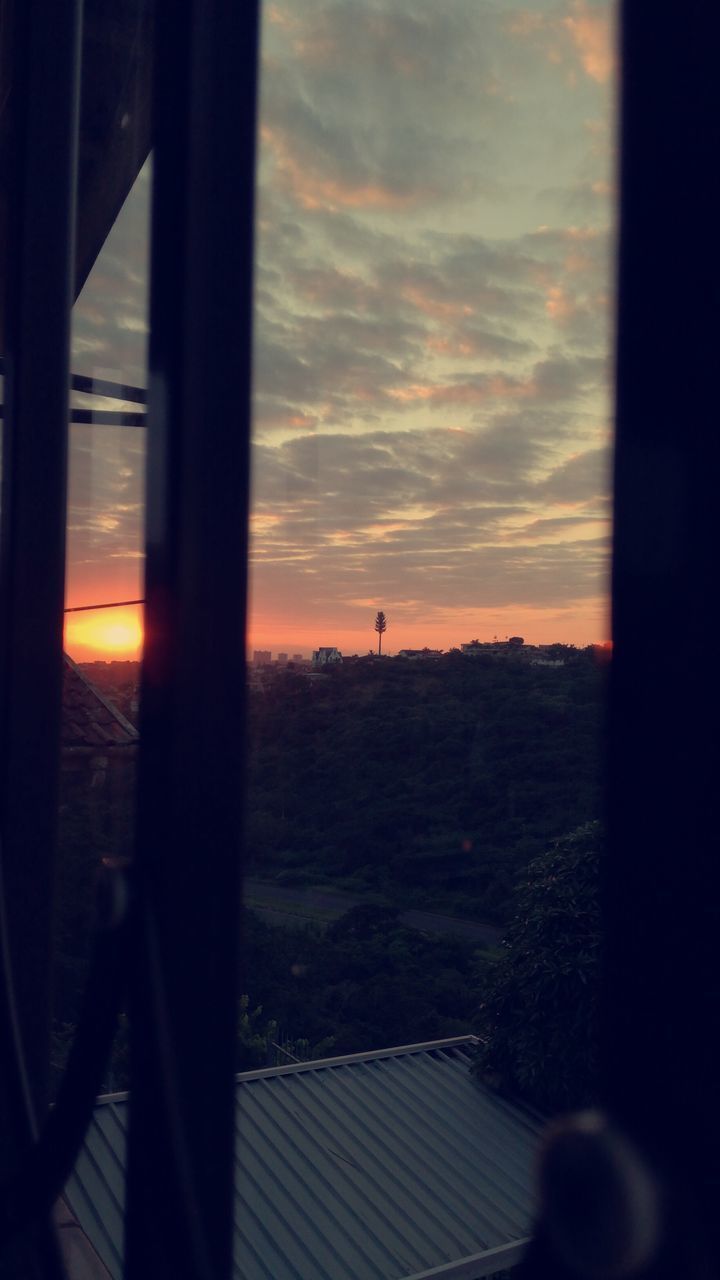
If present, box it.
[475,822,601,1111]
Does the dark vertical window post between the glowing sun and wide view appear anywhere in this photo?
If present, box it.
[127,0,258,1280]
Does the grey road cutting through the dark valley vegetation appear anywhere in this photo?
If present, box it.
[245,879,502,947]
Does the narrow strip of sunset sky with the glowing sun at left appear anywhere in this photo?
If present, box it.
[65,163,150,660]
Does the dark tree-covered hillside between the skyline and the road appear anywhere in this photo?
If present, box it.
[247,649,606,924]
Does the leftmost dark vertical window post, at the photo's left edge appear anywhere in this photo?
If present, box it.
[0,0,82,1276]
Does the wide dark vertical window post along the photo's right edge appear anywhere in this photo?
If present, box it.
[602,0,720,1262]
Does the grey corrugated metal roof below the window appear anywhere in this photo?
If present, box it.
[65,1037,541,1280]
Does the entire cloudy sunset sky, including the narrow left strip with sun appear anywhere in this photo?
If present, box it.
[68,0,614,657]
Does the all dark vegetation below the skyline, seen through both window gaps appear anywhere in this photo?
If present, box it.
[53,655,606,1095]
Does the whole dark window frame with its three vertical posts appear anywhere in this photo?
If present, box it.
[0,0,720,1277]
